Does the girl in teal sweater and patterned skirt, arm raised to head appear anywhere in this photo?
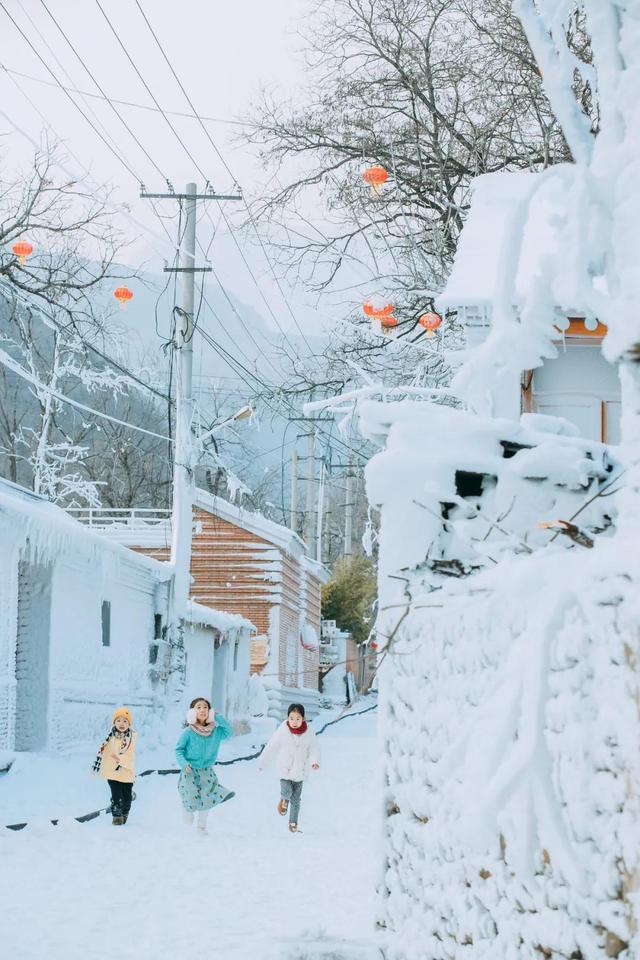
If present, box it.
[176,697,235,834]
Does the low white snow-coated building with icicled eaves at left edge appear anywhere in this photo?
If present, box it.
[0,483,170,750]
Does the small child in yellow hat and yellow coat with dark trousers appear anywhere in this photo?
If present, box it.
[93,707,137,827]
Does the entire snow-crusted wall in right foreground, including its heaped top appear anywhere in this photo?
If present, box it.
[359,401,640,960]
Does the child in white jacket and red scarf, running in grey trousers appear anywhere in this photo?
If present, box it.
[258,703,320,833]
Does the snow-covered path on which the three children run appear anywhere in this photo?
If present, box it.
[0,714,377,960]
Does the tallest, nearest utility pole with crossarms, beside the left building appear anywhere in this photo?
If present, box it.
[140,183,242,679]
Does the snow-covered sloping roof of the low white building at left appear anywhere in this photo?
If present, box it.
[0,477,172,581]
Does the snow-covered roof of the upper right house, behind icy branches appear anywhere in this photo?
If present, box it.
[438,170,562,309]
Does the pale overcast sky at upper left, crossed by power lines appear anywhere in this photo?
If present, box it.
[0,0,324,329]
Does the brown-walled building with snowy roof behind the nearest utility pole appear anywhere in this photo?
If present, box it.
[100,490,328,717]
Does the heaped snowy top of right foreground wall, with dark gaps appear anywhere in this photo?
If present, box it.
[358,400,615,602]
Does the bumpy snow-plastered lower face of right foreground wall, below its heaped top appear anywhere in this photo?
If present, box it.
[379,542,640,960]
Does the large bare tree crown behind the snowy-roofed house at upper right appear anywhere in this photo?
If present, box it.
[246,0,569,304]
